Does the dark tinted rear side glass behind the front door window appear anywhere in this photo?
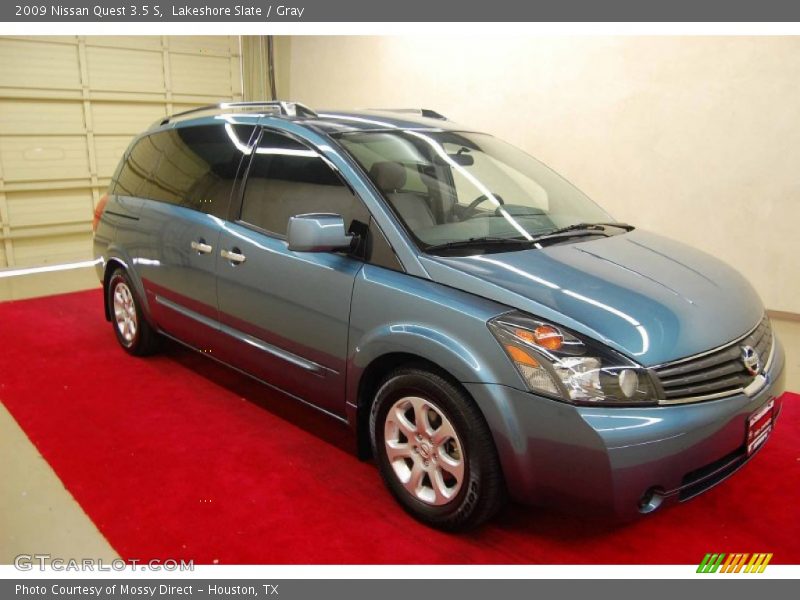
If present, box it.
[115,124,254,217]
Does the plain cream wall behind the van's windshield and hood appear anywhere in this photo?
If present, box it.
[288,36,800,313]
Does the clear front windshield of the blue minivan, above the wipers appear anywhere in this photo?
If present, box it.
[339,130,612,250]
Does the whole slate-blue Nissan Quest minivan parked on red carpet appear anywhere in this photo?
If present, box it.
[94,102,784,530]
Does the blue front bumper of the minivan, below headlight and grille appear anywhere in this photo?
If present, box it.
[465,340,785,518]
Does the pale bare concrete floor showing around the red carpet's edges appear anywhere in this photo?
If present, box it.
[0,268,800,564]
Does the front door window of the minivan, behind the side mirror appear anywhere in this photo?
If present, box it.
[241,132,369,235]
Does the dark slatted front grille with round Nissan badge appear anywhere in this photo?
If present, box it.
[653,317,772,401]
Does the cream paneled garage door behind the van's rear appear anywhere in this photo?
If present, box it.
[0,36,242,268]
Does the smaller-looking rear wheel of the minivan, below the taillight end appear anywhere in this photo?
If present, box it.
[107,269,159,356]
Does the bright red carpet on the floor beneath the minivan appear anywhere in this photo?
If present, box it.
[0,291,800,564]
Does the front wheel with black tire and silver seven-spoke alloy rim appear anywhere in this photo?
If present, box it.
[369,367,506,531]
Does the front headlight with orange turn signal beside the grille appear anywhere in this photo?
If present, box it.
[489,312,657,406]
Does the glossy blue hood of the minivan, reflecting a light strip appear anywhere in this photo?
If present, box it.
[423,230,764,366]
